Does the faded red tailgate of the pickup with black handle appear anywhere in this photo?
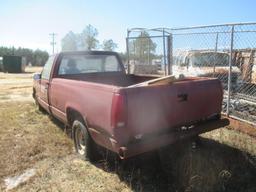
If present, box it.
[125,78,223,136]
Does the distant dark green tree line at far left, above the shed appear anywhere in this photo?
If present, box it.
[0,47,49,66]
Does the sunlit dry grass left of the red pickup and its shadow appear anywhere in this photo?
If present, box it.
[0,102,128,191]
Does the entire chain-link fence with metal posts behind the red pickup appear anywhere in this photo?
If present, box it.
[127,23,256,125]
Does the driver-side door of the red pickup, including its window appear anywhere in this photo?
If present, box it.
[38,56,55,112]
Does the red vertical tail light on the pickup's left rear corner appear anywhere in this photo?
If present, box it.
[111,93,127,128]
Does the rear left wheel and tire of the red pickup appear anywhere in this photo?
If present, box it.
[72,120,96,162]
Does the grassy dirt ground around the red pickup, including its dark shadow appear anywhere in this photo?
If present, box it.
[0,68,256,192]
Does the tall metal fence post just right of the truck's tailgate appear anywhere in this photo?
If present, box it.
[227,25,234,116]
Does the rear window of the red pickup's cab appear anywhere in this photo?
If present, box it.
[58,55,121,75]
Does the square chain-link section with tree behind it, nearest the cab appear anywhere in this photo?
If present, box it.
[126,28,170,75]
